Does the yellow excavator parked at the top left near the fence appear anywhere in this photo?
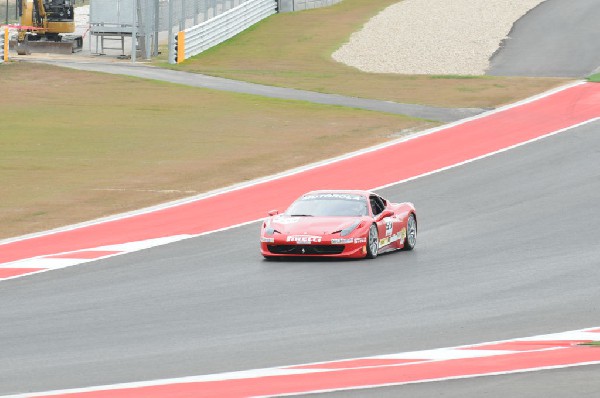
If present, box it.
[16,0,83,55]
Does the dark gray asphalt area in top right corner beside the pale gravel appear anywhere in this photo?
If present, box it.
[488,0,600,78]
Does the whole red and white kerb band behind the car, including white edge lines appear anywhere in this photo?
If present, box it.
[0,83,600,281]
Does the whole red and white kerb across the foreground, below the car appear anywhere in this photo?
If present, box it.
[0,327,600,398]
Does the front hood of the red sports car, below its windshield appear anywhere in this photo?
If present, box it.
[271,216,361,235]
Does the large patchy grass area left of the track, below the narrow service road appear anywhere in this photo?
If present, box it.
[0,63,433,238]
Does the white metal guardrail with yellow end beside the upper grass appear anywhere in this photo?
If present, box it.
[169,0,277,63]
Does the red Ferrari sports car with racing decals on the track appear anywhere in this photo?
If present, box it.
[260,191,417,259]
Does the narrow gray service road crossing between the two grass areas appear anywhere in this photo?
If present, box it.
[29,59,485,122]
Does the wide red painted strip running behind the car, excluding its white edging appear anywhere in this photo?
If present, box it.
[0,83,600,263]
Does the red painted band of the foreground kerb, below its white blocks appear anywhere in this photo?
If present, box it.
[34,346,600,398]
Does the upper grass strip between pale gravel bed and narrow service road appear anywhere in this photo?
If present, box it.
[156,0,568,108]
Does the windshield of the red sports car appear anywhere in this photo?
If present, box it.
[285,193,368,217]
